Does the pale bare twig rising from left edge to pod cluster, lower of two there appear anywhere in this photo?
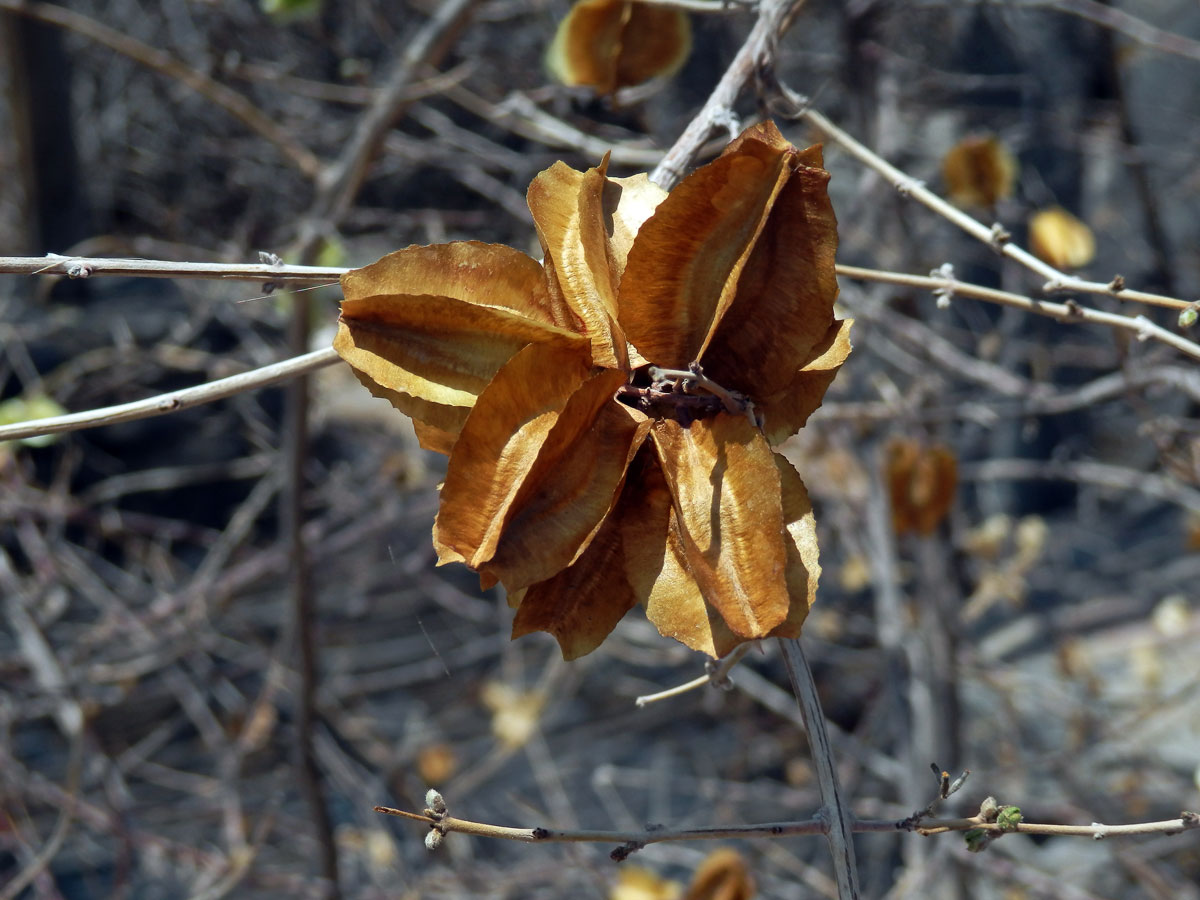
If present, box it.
[0,347,340,440]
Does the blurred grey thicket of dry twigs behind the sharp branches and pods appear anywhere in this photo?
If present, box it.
[0,0,1200,900]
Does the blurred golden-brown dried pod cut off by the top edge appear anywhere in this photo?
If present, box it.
[546,0,691,94]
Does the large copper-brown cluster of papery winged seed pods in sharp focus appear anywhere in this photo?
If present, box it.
[334,122,850,659]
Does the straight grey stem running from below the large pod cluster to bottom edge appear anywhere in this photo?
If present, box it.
[779,638,859,900]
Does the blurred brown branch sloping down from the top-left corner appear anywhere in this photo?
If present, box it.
[0,0,320,178]
